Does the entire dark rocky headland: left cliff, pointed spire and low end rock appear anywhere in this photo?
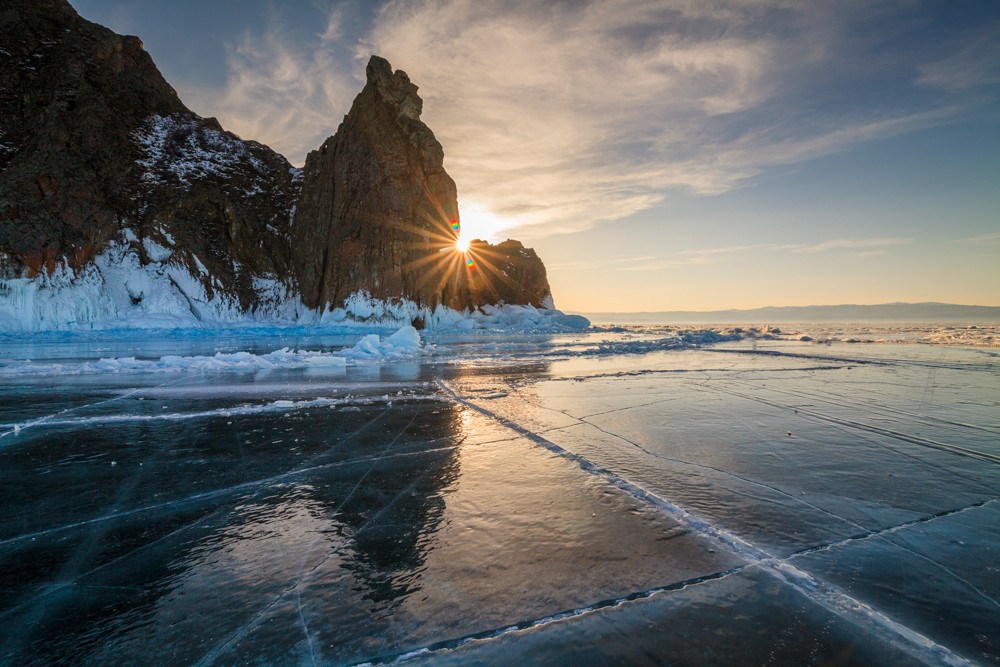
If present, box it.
[0,0,551,318]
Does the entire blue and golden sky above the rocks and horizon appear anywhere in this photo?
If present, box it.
[71,0,1000,312]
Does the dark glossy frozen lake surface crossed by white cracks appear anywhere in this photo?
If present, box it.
[0,327,1000,665]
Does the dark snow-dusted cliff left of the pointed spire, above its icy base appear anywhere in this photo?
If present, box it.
[0,0,298,308]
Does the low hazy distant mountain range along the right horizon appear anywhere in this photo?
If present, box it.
[584,303,1000,324]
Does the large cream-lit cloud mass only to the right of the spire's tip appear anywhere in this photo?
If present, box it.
[358,0,984,238]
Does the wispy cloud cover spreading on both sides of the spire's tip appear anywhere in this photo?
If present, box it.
[186,0,994,239]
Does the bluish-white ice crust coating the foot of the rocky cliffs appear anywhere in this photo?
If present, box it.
[0,237,590,332]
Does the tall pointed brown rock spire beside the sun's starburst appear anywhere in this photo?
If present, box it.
[292,56,461,307]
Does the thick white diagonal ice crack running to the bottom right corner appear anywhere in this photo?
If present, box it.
[436,380,973,665]
